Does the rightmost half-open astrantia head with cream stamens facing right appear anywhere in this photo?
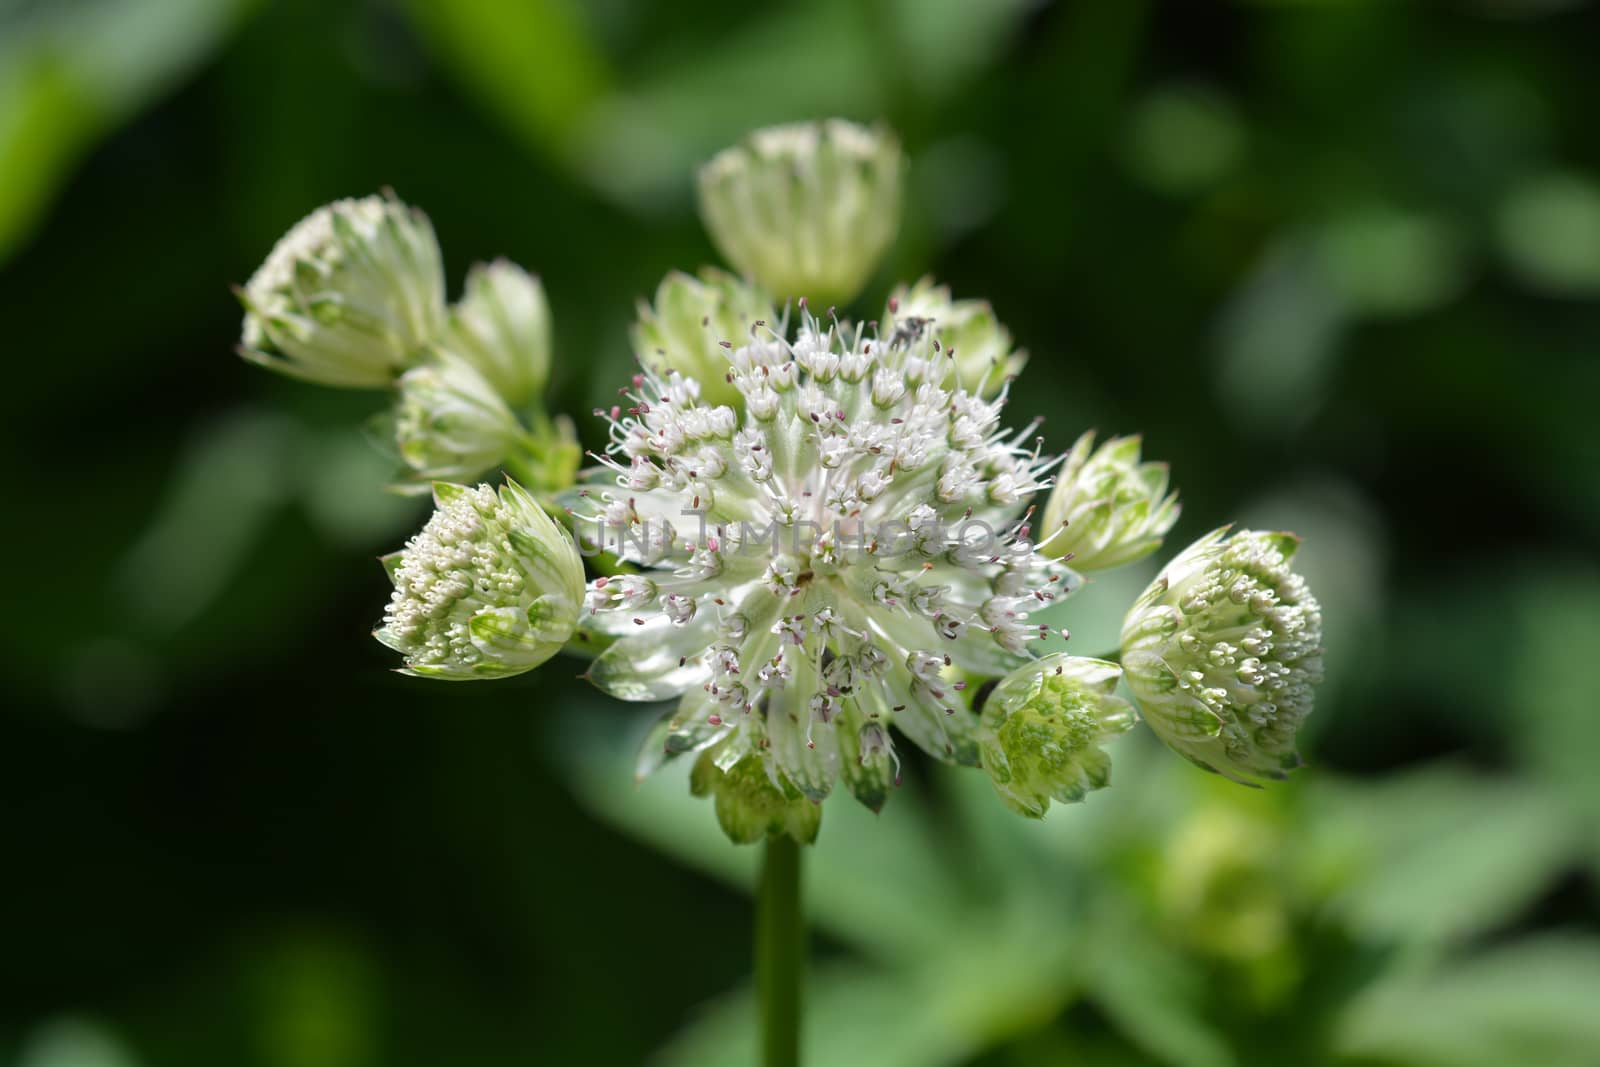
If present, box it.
[1122,528,1322,781]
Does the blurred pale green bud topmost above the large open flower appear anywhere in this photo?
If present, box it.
[699,118,904,307]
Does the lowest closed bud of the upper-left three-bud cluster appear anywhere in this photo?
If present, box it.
[395,352,522,490]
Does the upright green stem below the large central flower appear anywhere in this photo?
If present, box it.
[755,833,805,1067]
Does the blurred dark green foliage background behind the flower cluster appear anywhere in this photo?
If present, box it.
[0,0,1600,1067]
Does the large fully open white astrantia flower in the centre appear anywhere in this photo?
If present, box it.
[573,300,1070,831]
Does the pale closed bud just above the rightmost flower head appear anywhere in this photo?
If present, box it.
[1038,430,1178,573]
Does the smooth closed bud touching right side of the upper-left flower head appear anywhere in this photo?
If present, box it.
[443,259,550,408]
